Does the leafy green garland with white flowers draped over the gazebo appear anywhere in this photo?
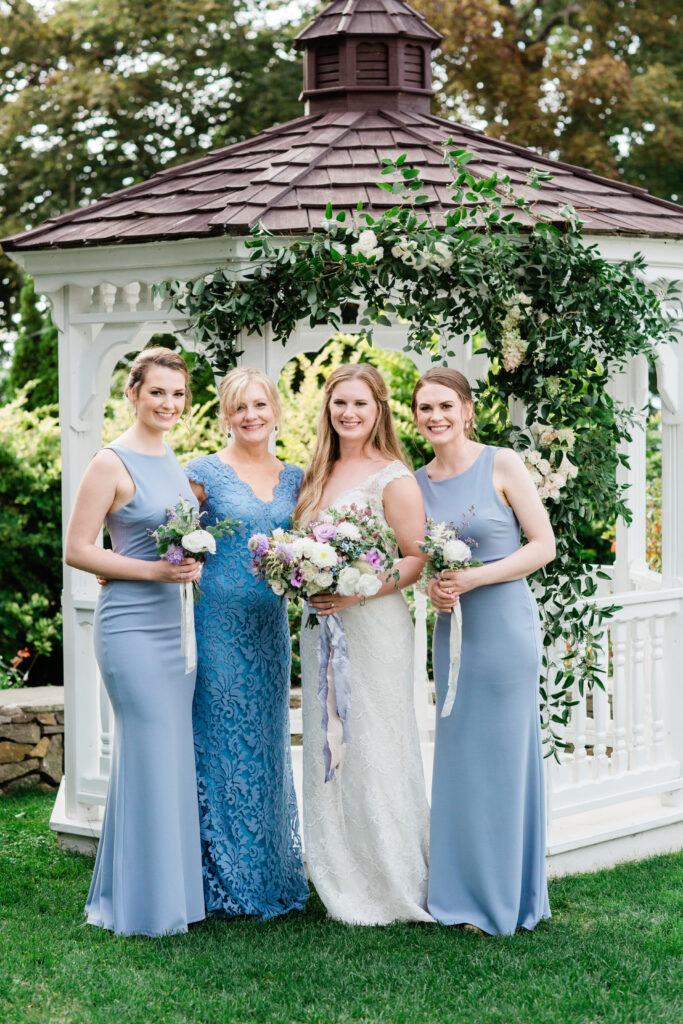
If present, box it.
[158,146,675,754]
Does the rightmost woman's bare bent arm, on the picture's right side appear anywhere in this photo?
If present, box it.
[438,449,555,603]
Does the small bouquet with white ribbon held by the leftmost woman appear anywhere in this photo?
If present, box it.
[152,497,240,674]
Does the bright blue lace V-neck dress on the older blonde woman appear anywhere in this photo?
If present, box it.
[185,455,308,919]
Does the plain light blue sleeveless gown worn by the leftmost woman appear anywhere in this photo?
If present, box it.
[85,444,205,935]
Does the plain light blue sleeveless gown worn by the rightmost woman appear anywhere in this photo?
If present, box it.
[416,446,550,934]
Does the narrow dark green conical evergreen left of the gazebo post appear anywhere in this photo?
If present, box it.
[6,278,59,409]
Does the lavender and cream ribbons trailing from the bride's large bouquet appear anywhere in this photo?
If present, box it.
[317,613,351,782]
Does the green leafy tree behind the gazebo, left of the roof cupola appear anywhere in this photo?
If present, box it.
[0,0,301,323]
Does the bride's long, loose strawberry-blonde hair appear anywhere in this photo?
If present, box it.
[294,362,408,525]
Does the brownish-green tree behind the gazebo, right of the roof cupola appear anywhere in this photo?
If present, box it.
[414,0,683,198]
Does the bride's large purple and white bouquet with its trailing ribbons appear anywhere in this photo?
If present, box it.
[248,505,397,782]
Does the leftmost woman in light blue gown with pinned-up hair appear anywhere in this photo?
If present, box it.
[66,348,205,936]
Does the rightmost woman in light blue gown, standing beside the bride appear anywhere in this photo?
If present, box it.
[413,368,555,935]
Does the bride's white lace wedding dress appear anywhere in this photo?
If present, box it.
[301,462,432,925]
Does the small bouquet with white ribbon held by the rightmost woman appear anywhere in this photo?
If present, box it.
[420,519,483,718]
